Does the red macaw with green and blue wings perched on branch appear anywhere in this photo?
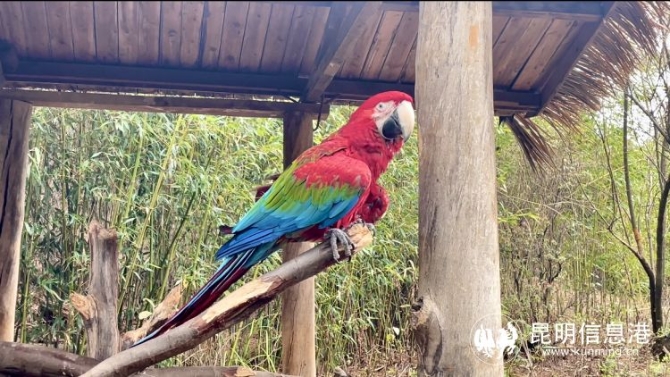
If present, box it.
[135,91,414,345]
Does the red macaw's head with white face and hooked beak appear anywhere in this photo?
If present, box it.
[351,91,414,145]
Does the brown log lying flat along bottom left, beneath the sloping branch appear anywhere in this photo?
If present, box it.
[0,342,290,377]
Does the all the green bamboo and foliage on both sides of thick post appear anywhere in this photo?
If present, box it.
[17,100,659,373]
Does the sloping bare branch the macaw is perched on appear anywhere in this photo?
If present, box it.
[83,224,372,377]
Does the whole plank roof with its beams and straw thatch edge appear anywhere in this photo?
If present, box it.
[0,1,669,163]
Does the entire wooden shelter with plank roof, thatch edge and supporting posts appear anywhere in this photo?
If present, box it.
[0,1,667,376]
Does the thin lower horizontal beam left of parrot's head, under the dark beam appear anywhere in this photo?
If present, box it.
[0,89,330,118]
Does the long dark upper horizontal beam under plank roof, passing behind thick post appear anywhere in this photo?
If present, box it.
[5,61,541,112]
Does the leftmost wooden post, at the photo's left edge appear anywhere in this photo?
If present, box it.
[0,99,32,342]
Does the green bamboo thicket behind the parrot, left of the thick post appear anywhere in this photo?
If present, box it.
[18,108,418,370]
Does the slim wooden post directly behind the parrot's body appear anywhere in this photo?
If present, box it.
[281,112,316,377]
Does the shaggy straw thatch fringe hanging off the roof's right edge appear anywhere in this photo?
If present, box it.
[502,1,670,166]
